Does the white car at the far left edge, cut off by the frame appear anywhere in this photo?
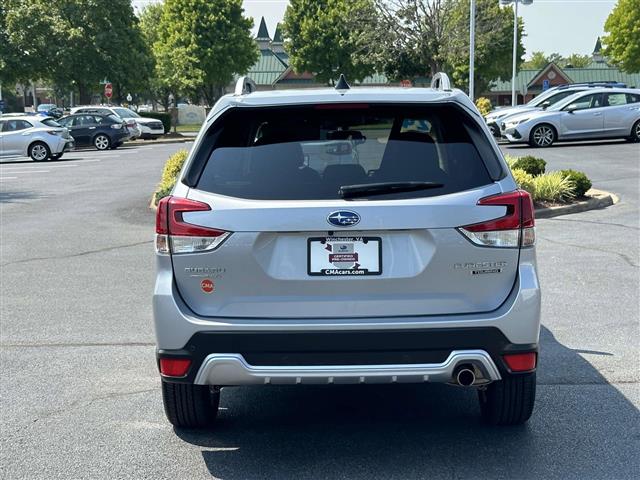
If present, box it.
[0,115,75,162]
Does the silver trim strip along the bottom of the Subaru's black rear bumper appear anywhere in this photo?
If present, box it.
[194,350,501,386]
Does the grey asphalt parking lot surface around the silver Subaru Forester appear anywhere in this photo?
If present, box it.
[0,142,640,479]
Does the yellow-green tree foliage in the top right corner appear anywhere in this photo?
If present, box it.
[602,0,640,73]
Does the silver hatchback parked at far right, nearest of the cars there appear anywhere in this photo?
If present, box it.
[500,88,640,147]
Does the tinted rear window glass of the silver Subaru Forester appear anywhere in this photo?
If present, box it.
[187,105,498,200]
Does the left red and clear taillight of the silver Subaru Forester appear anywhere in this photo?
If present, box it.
[156,197,231,255]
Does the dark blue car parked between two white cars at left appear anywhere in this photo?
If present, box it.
[58,113,130,150]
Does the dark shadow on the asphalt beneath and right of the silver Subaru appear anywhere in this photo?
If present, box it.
[176,328,640,480]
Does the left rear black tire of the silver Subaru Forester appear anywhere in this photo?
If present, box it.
[162,381,220,428]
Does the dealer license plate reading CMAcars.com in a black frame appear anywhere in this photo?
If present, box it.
[307,237,382,276]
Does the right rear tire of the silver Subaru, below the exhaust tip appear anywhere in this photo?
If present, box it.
[478,372,536,425]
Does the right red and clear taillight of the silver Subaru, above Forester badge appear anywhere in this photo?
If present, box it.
[459,190,536,248]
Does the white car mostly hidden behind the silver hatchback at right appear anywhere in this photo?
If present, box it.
[485,82,626,138]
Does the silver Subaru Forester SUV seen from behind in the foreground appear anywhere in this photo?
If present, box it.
[153,75,540,427]
